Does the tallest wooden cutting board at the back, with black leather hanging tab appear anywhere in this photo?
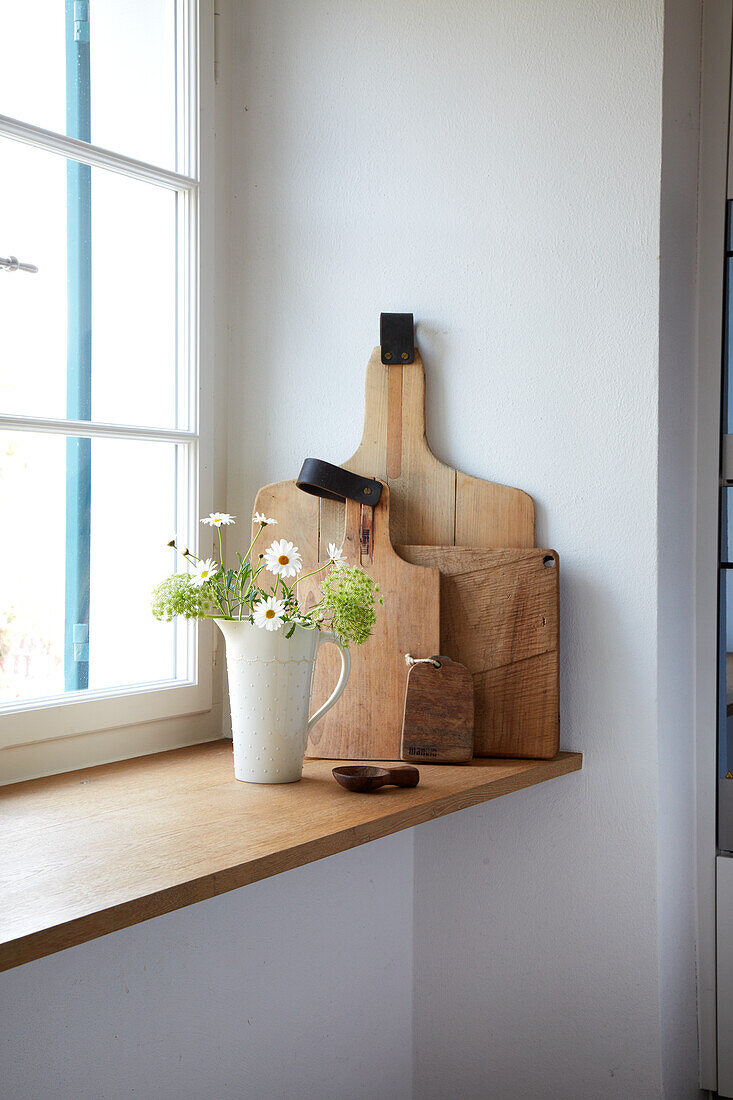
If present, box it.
[254,348,535,561]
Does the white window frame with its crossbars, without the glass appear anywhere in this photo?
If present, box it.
[0,0,220,784]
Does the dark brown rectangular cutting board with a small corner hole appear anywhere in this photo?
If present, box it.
[397,546,560,759]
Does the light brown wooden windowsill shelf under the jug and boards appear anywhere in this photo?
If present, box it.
[0,740,582,970]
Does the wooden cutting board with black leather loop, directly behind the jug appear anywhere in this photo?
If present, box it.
[297,485,440,760]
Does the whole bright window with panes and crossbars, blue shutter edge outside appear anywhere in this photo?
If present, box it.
[0,0,210,779]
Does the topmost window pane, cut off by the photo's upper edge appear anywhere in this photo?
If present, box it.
[0,0,177,168]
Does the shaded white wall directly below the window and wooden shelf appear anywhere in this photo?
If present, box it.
[0,833,413,1100]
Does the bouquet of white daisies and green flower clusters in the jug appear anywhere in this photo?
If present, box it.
[152,512,382,646]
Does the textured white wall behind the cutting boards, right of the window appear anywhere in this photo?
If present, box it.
[227,0,696,1100]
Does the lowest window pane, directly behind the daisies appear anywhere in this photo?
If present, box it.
[0,431,188,704]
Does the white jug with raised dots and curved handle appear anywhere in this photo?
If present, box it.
[216,619,351,783]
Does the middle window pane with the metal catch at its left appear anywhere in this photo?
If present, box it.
[0,139,179,428]
